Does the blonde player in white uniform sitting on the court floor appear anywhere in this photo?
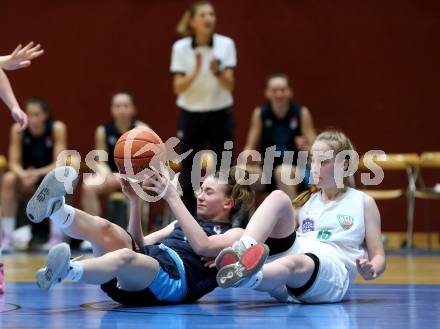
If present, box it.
[216,131,386,303]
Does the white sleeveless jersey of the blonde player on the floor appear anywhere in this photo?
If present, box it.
[293,188,366,281]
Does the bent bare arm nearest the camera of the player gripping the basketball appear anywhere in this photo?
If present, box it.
[143,171,243,256]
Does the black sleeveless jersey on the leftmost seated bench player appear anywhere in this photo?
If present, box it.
[21,120,54,169]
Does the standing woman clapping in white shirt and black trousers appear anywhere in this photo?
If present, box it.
[170,1,237,213]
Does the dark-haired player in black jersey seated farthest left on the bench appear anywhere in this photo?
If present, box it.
[0,97,66,248]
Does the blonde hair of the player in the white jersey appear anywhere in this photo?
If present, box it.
[292,130,355,208]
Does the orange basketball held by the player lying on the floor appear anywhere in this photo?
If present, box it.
[113,127,165,175]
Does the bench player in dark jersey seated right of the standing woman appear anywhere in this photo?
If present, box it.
[244,74,315,199]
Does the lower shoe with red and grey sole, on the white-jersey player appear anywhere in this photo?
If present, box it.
[216,243,269,288]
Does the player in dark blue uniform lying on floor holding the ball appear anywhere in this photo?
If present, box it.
[27,167,254,306]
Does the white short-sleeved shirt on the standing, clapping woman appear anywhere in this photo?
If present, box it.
[170,33,237,112]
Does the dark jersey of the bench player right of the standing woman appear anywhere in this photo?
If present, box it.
[260,102,302,166]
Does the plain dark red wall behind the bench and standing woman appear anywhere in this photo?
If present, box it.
[0,0,440,230]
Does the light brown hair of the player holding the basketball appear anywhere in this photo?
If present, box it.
[214,166,255,222]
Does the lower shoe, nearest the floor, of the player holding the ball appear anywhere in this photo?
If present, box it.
[35,243,70,290]
